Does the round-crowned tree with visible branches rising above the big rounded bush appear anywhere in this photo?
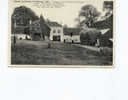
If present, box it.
[79,5,100,27]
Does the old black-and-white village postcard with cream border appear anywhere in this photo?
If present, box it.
[8,0,115,68]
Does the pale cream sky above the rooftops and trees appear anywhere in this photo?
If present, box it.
[9,0,113,27]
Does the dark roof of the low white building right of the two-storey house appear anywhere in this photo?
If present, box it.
[63,28,80,35]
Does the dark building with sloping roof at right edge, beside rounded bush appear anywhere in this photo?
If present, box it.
[93,15,113,47]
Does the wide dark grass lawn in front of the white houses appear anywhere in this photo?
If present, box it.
[11,40,112,65]
